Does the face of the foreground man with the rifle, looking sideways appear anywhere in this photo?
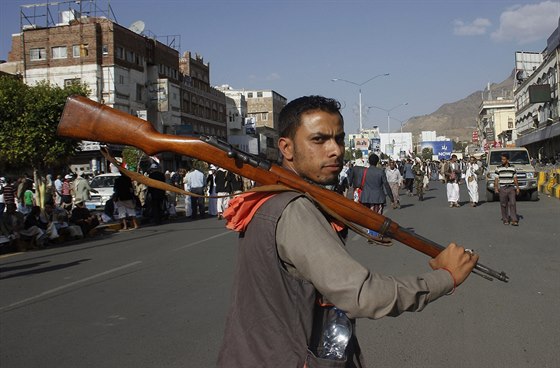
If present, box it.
[278,110,344,185]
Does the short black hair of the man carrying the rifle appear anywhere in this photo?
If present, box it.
[278,96,344,139]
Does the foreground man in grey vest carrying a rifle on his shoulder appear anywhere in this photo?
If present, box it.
[218,96,478,368]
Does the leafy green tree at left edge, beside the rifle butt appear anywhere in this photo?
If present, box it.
[0,76,89,203]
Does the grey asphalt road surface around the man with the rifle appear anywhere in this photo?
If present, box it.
[0,183,560,368]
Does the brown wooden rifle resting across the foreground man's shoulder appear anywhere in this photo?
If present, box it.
[57,96,509,282]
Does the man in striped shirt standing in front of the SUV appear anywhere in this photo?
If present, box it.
[494,152,519,226]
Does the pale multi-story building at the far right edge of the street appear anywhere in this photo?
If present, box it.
[514,19,560,159]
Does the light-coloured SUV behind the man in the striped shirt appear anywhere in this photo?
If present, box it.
[486,147,539,202]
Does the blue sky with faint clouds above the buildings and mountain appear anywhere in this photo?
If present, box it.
[0,0,560,133]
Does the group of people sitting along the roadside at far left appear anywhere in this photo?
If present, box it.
[0,198,99,251]
